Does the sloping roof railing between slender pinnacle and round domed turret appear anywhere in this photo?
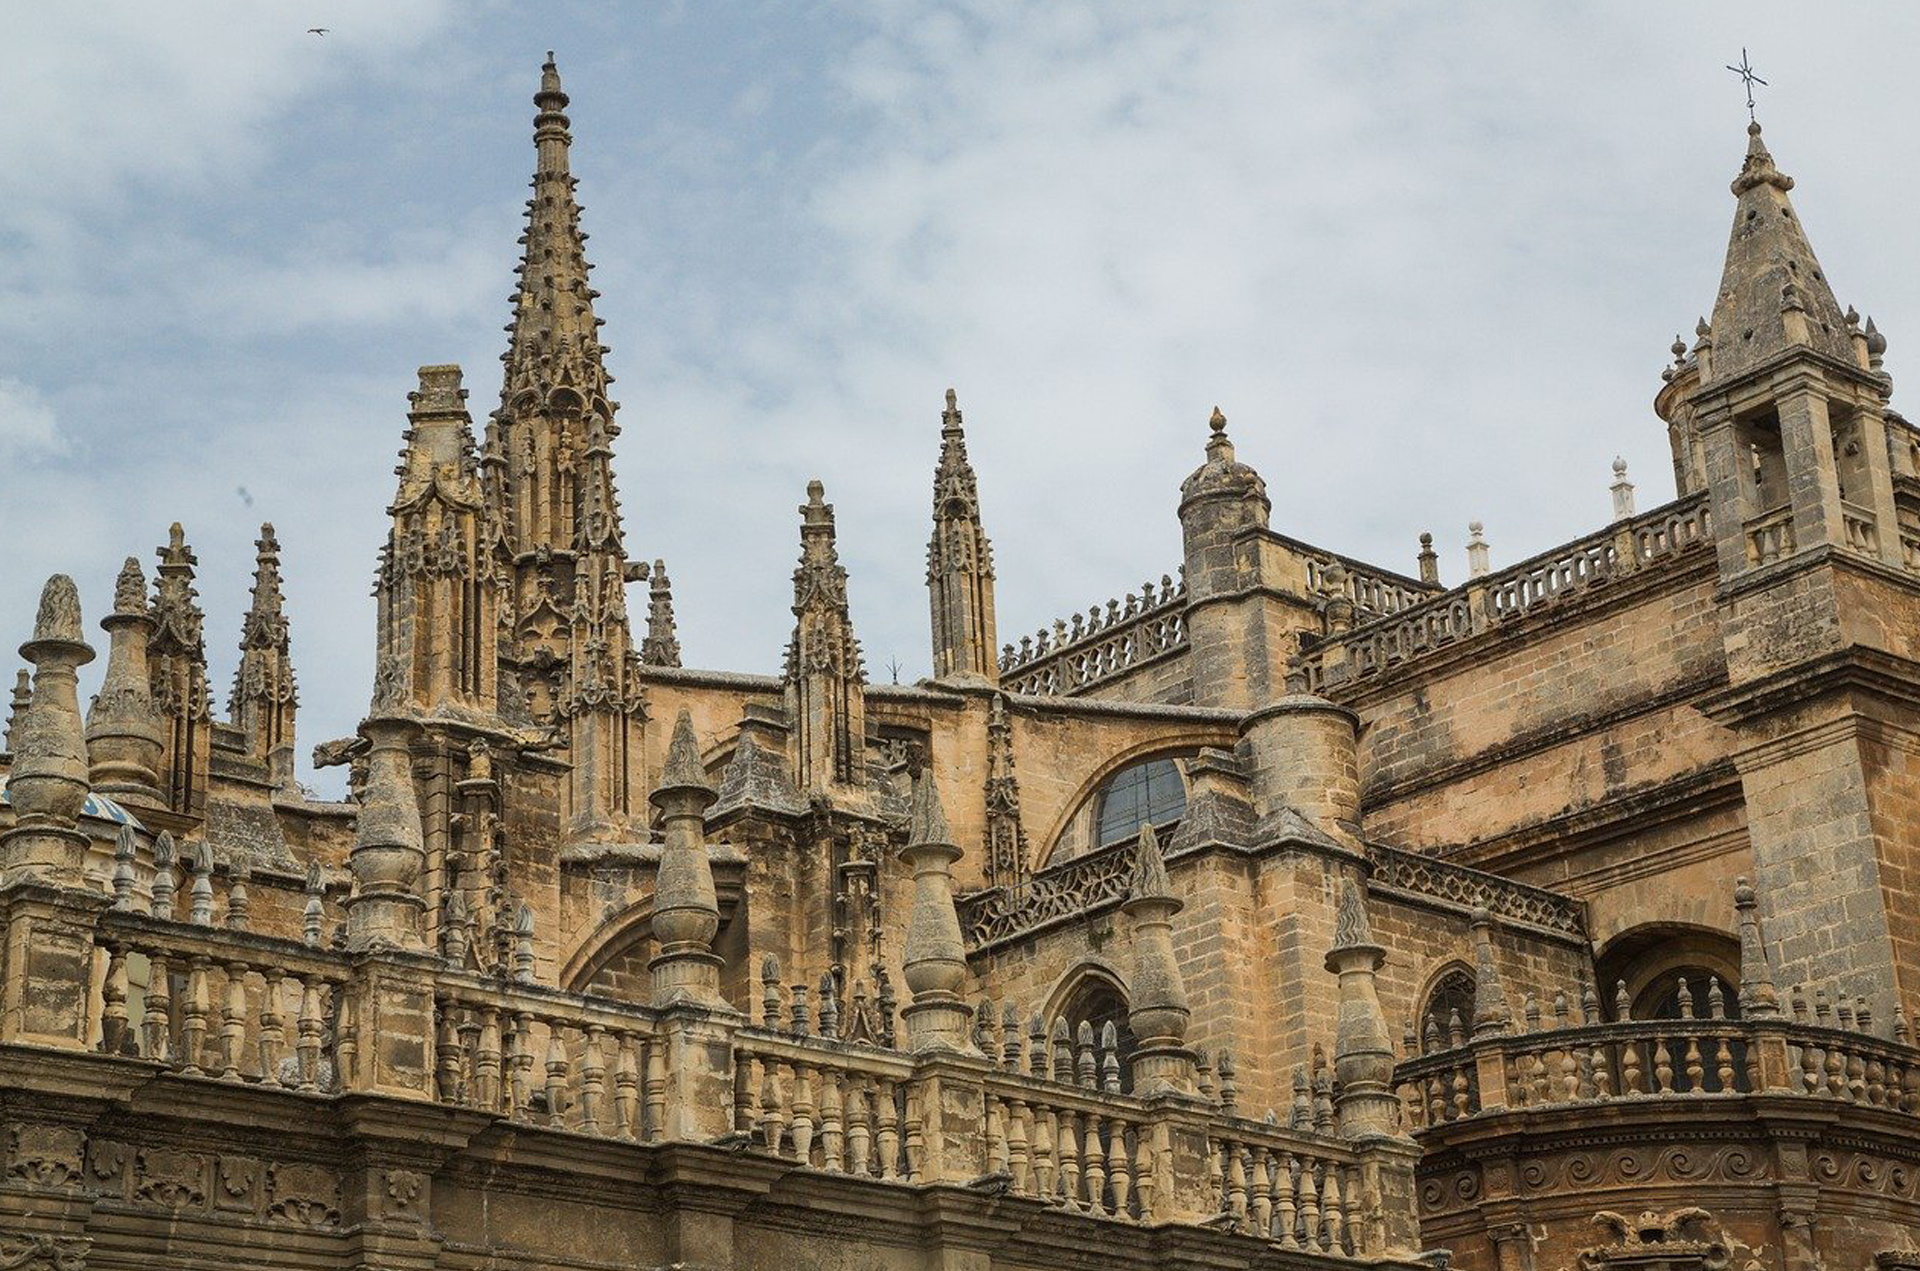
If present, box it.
[1000,574,1187,697]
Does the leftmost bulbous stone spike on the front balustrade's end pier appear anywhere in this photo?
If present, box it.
[0,574,94,887]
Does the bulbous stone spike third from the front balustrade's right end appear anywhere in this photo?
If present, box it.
[900,772,975,1054]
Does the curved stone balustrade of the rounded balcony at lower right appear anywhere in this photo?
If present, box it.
[1394,985,1920,1127]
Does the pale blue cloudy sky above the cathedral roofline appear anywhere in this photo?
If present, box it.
[0,0,1920,791]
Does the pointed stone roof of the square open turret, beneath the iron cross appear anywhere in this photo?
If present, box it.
[1713,123,1853,380]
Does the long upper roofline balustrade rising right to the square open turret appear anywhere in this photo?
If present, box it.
[1294,493,1713,693]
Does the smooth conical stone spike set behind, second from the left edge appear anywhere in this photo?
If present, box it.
[86,557,161,804]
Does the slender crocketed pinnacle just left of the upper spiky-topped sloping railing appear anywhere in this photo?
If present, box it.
[927,388,1000,683]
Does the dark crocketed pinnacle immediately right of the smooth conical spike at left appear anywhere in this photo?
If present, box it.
[148,522,213,816]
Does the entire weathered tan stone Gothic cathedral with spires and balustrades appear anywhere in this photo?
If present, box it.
[0,61,1920,1271]
